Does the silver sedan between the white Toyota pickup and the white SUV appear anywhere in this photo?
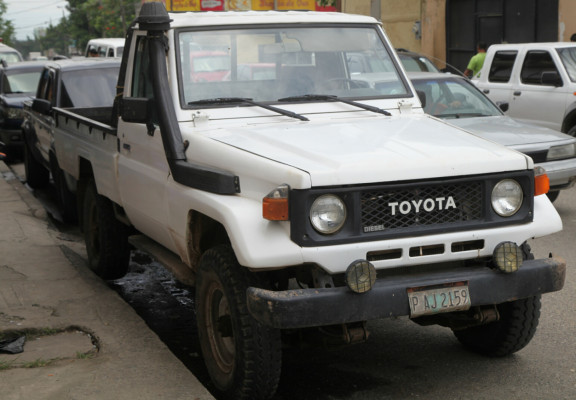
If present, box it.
[408,72,576,201]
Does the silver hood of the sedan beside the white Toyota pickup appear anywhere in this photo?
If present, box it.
[445,116,574,147]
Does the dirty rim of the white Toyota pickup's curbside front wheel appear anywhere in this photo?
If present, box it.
[205,283,236,374]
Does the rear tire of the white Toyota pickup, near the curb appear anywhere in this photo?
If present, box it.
[82,180,130,280]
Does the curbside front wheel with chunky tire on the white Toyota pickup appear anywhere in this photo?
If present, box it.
[196,245,282,399]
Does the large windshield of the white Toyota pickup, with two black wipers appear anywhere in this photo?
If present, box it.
[179,26,409,108]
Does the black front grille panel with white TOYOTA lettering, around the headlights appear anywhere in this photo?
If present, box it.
[290,170,534,247]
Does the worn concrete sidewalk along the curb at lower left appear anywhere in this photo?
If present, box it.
[0,162,213,400]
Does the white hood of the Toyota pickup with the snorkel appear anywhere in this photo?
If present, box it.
[200,114,532,186]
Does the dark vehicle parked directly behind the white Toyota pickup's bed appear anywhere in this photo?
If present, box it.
[21,58,120,222]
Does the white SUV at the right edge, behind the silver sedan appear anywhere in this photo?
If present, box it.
[473,42,576,136]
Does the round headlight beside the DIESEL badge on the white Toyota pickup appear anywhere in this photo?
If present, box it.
[310,194,346,235]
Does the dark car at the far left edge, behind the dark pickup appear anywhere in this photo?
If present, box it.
[0,61,44,161]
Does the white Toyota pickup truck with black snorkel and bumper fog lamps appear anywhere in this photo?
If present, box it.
[23,3,566,399]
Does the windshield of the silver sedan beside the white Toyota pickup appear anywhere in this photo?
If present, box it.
[412,78,502,118]
